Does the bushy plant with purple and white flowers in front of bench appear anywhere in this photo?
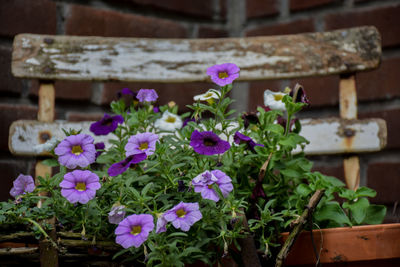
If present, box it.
[0,63,394,266]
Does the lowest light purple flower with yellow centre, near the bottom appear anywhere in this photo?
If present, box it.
[115,214,154,248]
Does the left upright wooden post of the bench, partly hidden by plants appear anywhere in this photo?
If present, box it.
[35,83,58,267]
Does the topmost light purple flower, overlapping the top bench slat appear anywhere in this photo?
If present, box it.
[207,63,240,86]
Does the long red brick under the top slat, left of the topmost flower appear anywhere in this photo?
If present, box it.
[101,83,213,112]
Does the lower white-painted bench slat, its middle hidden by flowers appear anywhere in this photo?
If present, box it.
[9,119,386,156]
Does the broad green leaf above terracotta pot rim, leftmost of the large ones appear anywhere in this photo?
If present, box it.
[314,202,351,226]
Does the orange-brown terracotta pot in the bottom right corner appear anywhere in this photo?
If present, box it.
[282,223,400,266]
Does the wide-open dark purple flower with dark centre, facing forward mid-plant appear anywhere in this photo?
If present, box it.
[190,130,231,155]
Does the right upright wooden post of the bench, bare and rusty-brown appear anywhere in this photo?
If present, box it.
[339,75,360,190]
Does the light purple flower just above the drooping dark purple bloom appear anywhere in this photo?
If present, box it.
[125,132,158,156]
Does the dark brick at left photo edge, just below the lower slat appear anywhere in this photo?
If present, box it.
[0,159,34,201]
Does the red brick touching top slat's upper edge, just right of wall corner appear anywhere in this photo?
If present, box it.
[246,19,315,36]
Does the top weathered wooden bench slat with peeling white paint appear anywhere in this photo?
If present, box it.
[12,27,381,82]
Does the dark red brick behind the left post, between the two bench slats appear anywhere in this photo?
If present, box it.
[29,80,92,100]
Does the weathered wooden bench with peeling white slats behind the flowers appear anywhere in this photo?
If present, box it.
[9,24,387,266]
